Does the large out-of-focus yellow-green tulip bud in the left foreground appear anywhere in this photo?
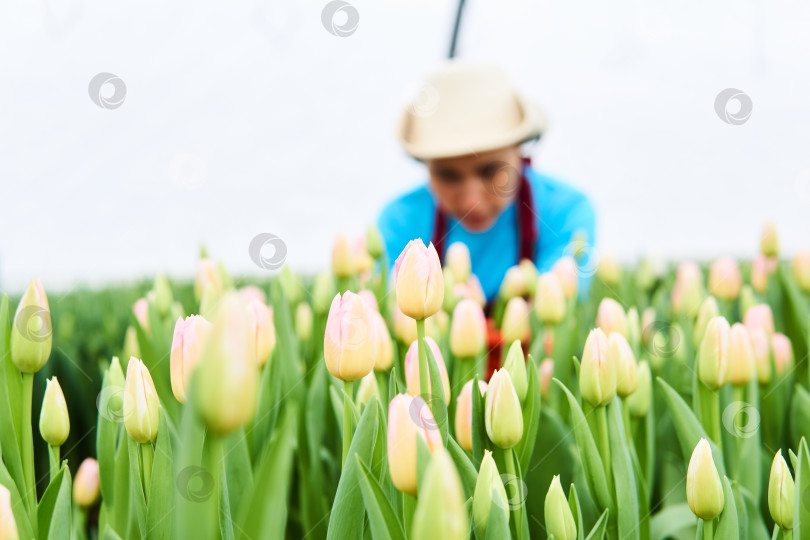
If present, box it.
[194,293,259,435]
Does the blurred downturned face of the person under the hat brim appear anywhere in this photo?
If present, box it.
[425,146,521,232]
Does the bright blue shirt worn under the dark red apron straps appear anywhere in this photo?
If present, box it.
[378,167,596,300]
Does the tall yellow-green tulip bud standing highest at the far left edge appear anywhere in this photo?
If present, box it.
[11,279,53,373]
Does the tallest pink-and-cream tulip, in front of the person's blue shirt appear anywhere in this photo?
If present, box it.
[394,238,444,321]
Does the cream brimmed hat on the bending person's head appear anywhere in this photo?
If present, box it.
[397,60,546,160]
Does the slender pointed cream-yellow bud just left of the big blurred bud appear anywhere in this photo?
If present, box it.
[124,358,160,444]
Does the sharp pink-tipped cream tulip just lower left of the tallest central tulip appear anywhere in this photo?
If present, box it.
[323,291,377,381]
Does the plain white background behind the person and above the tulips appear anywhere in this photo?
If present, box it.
[0,0,810,290]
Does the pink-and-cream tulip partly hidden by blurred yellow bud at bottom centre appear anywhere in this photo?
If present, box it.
[388,394,443,495]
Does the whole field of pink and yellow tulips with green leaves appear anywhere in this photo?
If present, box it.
[0,221,810,540]
